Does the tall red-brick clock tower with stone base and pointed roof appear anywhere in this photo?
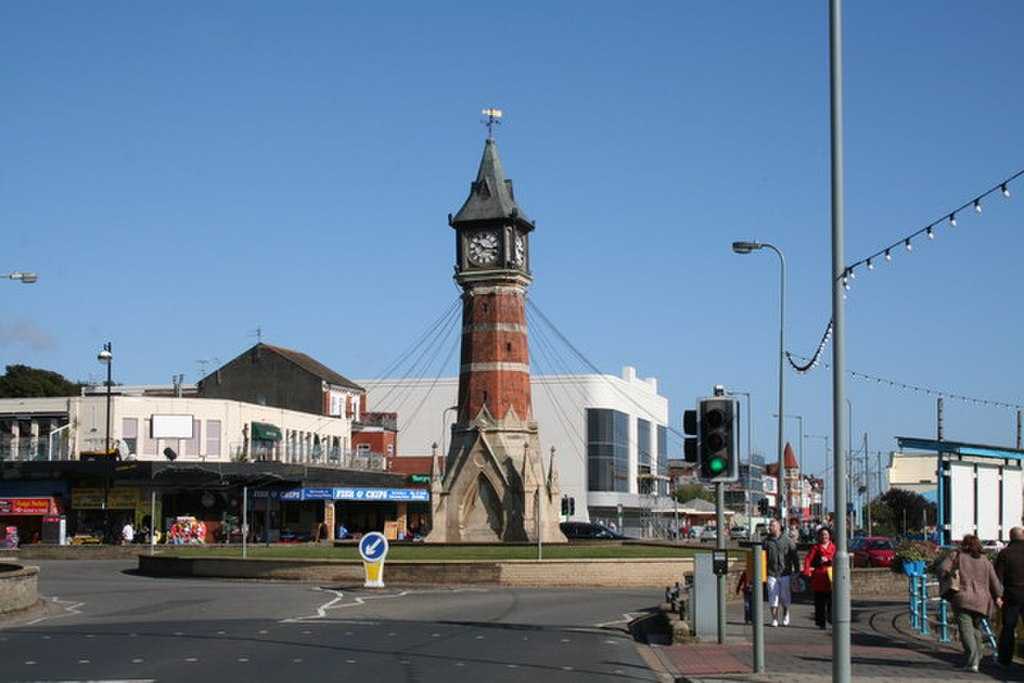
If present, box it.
[427,136,565,543]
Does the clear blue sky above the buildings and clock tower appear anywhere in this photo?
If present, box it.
[0,1,1024,483]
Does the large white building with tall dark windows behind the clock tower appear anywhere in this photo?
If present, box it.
[357,367,674,537]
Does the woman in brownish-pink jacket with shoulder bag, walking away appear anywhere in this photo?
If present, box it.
[938,533,1013,673]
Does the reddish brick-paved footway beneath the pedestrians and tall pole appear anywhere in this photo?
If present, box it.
[656,602,1024,683]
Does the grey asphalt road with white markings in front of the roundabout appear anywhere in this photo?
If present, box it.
[0,561,660,683]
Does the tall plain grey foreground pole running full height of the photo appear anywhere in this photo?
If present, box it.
[827,0,850,683]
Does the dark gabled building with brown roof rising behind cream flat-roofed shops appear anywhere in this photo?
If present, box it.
[198,342,366,422]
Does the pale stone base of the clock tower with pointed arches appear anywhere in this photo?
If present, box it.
[426,410,565,543]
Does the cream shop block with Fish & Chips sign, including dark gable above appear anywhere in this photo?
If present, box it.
[0,343,430,542]
